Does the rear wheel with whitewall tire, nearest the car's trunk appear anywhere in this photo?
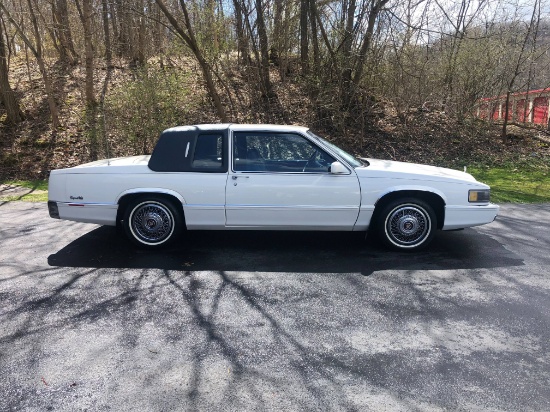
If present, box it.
[124,196,183,249]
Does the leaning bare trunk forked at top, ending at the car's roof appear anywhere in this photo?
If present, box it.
[155,0,228,122]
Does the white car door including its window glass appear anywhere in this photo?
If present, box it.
[225,131,360,230]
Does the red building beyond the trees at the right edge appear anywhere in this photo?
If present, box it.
[476,87,550,126]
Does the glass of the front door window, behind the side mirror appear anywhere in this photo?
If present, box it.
[233,132,334,173]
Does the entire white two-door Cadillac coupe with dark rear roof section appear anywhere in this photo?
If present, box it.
[48,124,498,250]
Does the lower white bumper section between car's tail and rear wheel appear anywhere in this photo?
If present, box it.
[48,200,118,226]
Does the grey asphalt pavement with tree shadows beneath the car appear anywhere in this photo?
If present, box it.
[0,203,550,411]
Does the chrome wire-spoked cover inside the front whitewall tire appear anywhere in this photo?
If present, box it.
[386,205,431,245]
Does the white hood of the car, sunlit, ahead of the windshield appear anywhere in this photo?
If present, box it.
[355,159,477,183]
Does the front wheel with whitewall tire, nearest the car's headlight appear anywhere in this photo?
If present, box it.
[377,198,437,251]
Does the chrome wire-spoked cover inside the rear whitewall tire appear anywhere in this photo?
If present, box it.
[131,203,174,243]
